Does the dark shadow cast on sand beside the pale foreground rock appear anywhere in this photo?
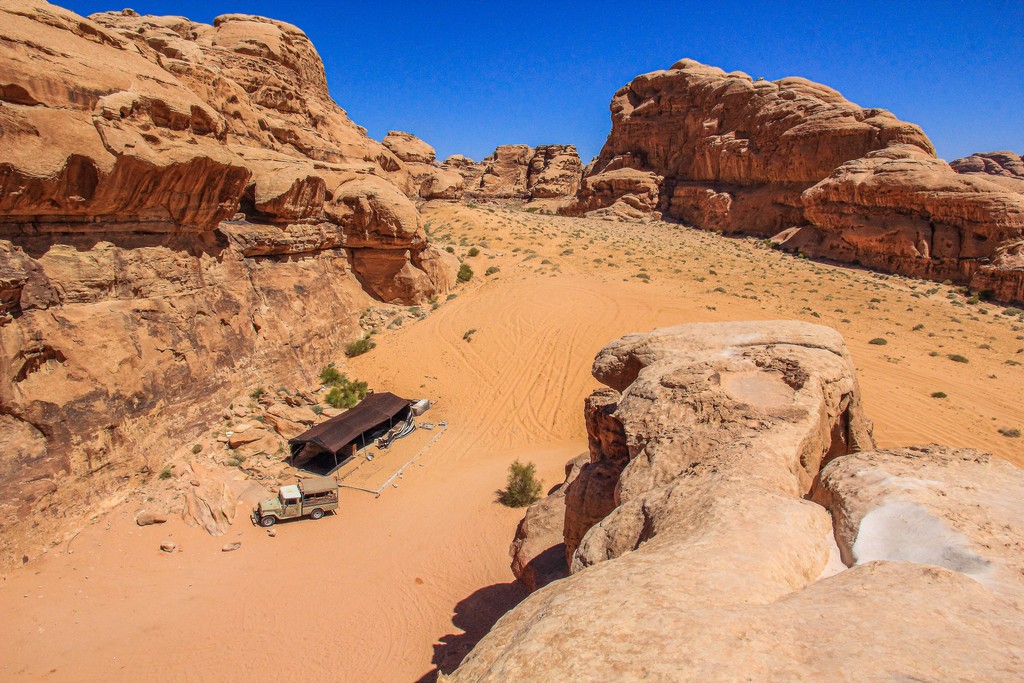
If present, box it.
[417,582,528,683]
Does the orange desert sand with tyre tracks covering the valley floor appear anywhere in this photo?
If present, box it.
[0,203,1024,681]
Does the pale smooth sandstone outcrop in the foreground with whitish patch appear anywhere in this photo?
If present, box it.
[449,323,1024,681]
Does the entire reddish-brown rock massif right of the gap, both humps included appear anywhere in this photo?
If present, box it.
[563,59,1024,300]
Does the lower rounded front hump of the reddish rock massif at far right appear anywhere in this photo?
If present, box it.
[777,145,1024,290]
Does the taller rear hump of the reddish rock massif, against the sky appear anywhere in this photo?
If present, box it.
[573,59,934,229]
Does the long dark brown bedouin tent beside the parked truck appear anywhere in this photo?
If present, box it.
[288,391,413,467]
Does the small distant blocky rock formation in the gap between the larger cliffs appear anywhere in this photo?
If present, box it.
[456,144,583,201]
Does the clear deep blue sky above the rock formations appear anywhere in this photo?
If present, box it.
[57,0,1024,163]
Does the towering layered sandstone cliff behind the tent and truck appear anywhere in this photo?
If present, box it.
[0,0,454,557]
